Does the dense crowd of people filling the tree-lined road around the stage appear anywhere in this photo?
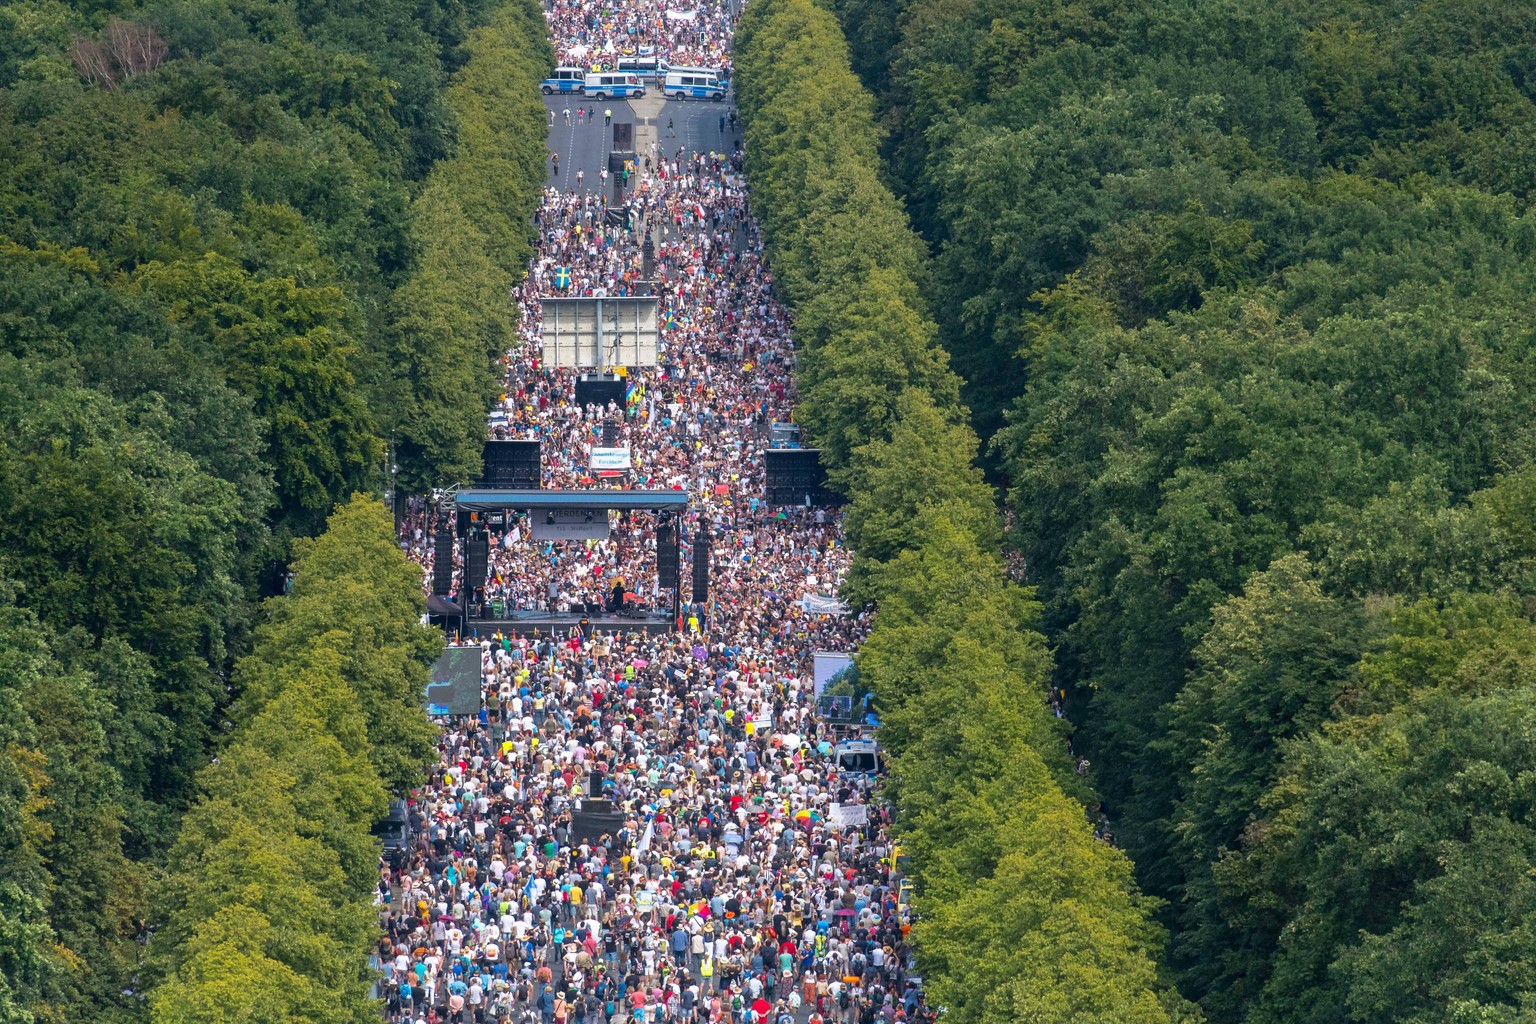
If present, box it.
[378,0,932,1024]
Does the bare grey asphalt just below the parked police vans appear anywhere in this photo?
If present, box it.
[544,91,740,200]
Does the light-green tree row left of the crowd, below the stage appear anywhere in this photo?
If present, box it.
[146,496,442,1024]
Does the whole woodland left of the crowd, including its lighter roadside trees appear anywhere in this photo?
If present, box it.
[0,0,553,1024]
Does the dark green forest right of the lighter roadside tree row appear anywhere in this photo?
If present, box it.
[836,0,1536,1024]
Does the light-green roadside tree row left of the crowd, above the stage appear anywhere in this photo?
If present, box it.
[384,0,553,493]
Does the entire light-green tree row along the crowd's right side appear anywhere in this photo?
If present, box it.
[736,0,1192,1024]
